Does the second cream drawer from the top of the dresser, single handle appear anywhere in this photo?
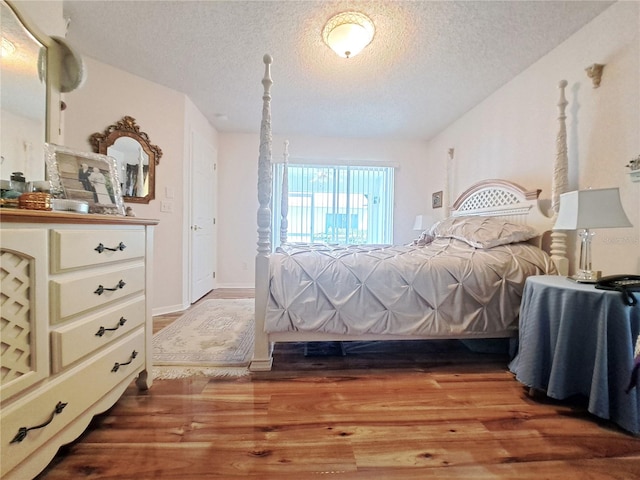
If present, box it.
[49,262,145,324]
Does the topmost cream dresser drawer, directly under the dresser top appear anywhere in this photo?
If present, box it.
[51,229,145,273]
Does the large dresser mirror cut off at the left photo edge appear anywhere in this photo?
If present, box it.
[0,1,48,180]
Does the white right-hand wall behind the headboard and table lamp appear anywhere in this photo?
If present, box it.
[427,2,640,274]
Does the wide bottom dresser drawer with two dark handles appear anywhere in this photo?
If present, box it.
[0,329,145,473]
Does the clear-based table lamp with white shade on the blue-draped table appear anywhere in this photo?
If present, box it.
[553,188,633,283]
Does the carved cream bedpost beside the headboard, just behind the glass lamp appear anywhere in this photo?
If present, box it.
[550,80,569,275]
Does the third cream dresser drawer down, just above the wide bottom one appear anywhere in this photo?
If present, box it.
[51,296,145,373]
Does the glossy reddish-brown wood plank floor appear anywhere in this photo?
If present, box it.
[38,291,640,480]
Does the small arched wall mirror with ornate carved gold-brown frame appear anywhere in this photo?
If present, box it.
[89,116,162,203]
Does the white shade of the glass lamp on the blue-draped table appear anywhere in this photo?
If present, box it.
[553,188,633,230]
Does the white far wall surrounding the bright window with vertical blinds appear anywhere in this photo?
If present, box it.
[218,133,432,287]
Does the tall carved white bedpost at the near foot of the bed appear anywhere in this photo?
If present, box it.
[249,55,273,371]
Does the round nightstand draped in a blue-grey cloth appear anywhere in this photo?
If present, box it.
[509,275,640,434]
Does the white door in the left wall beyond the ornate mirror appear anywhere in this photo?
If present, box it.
[189,132,218,303]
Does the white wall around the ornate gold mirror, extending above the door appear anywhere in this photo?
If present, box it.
[63,57,214,314]
